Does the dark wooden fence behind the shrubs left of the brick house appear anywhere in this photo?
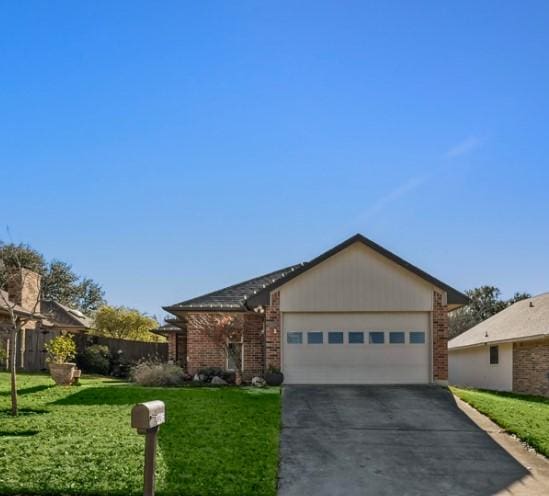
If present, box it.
[18,330,168,372]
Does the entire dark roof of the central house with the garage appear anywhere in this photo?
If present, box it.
[164,234,469,312]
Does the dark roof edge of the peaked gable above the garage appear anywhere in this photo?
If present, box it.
[248,234,469,307]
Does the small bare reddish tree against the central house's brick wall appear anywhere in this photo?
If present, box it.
[191,314,244,384]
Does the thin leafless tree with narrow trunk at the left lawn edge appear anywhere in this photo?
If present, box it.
[0,243,41,416]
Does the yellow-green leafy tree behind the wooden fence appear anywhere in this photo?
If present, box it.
[94,305,164,341]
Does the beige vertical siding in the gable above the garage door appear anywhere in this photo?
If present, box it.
[280,243,433,312]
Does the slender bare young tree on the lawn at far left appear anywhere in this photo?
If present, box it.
[0,244,41,416]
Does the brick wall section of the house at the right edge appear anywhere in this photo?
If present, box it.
[513,340,549,396]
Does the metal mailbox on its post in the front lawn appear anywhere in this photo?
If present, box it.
[132,400,166,496]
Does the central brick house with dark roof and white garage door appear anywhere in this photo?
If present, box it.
[164,234,468,384]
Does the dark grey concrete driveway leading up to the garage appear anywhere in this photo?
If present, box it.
[278,386,528,496]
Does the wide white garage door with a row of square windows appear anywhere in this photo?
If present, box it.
[282,312,431,384]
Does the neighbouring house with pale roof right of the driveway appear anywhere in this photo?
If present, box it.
[448,293,549,396]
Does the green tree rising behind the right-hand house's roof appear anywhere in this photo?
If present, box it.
[449,286,531,338]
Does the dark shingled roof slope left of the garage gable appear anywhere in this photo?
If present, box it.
[163,264,301,313]
